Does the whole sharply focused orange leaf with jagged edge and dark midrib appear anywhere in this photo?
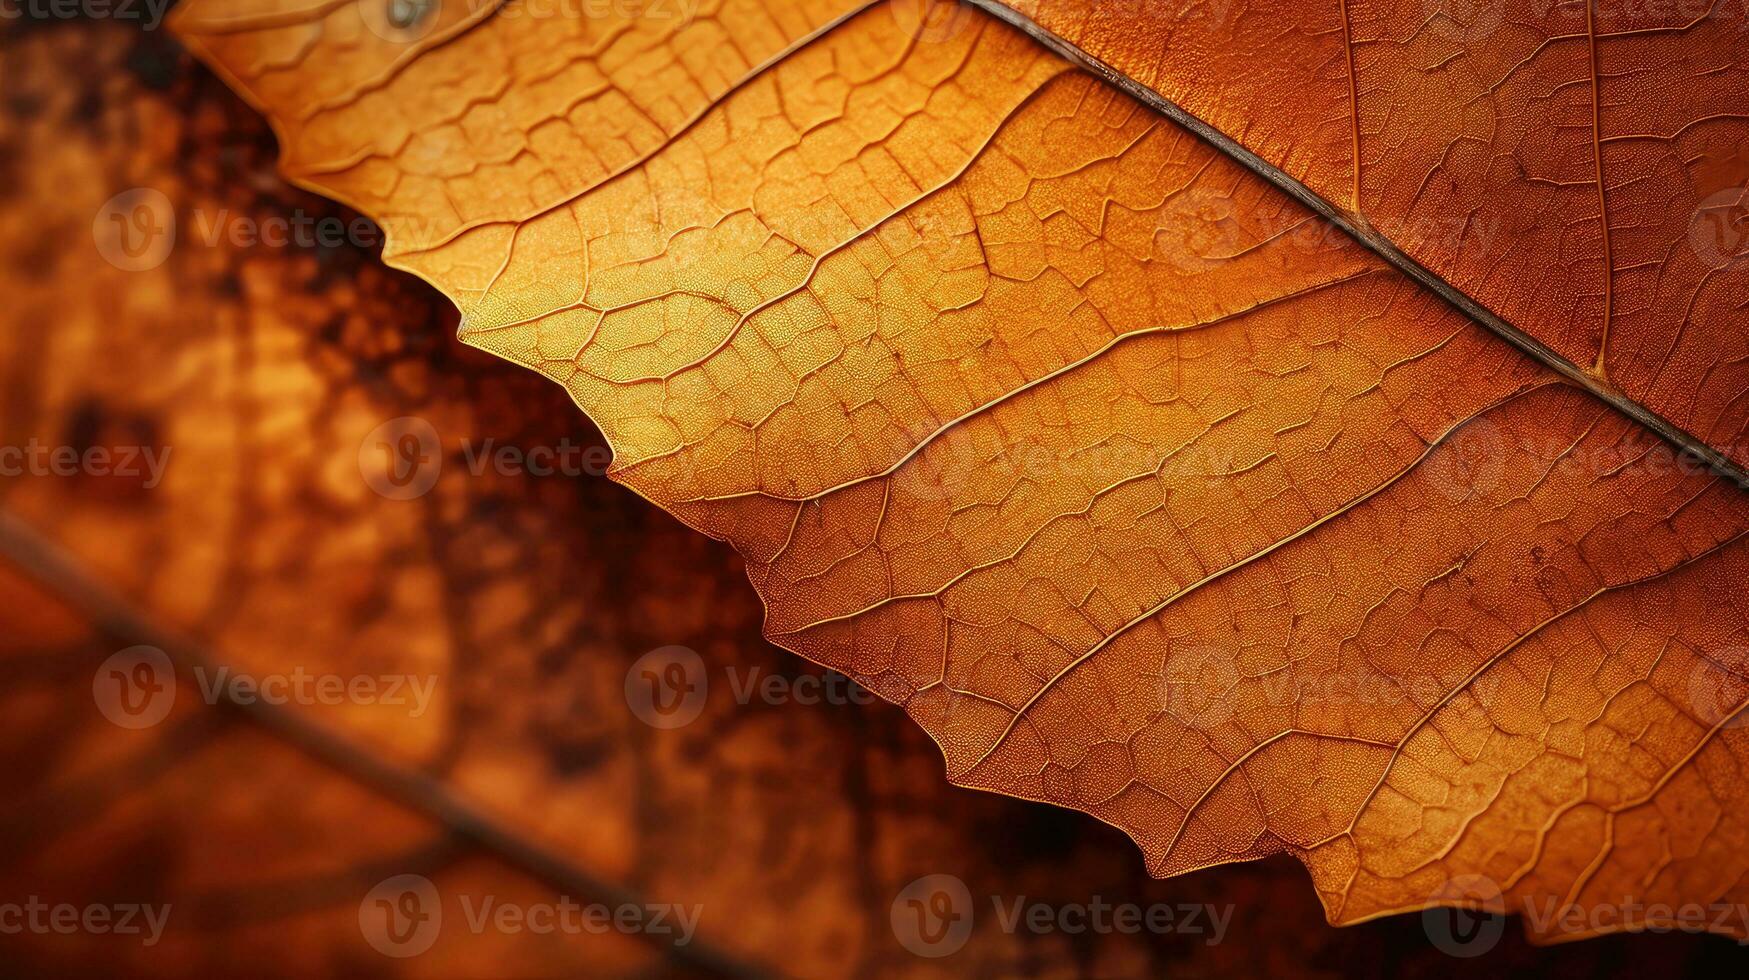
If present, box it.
[167,0,1749,940]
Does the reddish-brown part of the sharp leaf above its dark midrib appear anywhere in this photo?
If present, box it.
[1000,0,1749,464]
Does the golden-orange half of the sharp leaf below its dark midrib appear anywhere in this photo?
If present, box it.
[178,0,1749,938]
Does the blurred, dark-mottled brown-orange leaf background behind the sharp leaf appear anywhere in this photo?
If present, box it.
[0,7,1742,977]
